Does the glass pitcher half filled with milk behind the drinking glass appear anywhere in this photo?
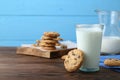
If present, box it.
[96,10,120,54]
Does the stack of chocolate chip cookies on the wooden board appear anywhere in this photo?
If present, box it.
[32,32,62,50]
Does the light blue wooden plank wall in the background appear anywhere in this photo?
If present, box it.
[0,0,120,46]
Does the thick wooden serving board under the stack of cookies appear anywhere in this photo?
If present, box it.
[16,47,74,58]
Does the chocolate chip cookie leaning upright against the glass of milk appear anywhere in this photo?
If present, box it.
[64,49,84,72]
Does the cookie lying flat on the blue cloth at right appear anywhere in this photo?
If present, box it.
[104,58,120,66]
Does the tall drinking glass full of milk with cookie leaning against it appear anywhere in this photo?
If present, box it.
[76,24,103,72]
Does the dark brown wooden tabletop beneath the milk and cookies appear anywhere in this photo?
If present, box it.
[0,47,120,80]
